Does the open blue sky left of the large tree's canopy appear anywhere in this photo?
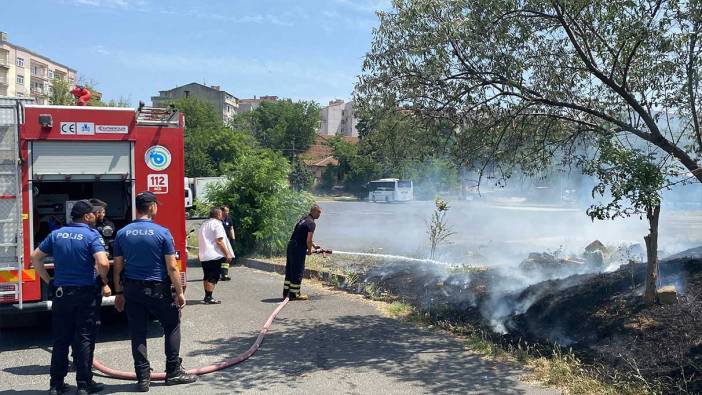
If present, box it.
[0,0,390,106]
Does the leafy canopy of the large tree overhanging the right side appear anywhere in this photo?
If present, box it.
[364,0,702,304]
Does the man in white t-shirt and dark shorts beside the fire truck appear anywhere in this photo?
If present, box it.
[197,208,234,304]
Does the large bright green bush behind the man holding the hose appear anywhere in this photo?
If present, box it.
[208,148,313,255]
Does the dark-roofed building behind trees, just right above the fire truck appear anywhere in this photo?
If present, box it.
[151,82,239,123]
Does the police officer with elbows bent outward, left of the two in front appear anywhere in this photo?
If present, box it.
[32,200,110,394]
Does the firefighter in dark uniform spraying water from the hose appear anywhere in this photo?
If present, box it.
[283,204,322,300]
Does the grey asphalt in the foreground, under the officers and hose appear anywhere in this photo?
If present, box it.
[0,267,554,394]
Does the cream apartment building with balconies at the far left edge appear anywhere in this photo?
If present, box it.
[0,32,77,104]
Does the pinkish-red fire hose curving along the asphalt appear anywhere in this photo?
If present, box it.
[93,298,289,380]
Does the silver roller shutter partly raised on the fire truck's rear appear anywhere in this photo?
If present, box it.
[32,141,132,181]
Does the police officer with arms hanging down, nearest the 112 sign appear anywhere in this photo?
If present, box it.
[113,192,197,392]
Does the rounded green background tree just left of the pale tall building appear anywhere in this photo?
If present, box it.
[232,99,319,158]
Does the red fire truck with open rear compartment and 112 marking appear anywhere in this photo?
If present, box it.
[0,97,187,315]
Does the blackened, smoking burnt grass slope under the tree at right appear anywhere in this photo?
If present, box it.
[346,247,702,393]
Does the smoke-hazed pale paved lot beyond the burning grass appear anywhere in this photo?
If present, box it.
[315,201,702,263]
